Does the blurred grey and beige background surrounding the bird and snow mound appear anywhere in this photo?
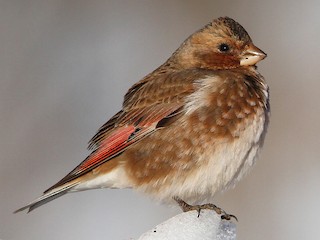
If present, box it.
[0,0,320,240]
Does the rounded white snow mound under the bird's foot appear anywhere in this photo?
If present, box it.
[138,210,236,240]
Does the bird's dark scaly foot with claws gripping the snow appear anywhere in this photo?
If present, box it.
[173,197,238,221]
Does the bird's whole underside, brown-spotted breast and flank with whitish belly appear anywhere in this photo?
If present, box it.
[123,71,268,201]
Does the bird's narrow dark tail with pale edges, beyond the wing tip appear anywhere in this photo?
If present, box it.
[14,182,78,213]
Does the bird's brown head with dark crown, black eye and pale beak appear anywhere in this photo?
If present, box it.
[171,17,267,70]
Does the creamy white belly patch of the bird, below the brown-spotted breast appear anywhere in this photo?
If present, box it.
[146,111,266,203]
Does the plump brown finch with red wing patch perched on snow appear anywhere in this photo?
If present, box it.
[15,17,270,216]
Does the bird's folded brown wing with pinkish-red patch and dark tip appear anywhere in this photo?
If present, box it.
[44,70,198,193]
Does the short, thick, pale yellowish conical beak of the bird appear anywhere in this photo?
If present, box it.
[240,43,267,66]
